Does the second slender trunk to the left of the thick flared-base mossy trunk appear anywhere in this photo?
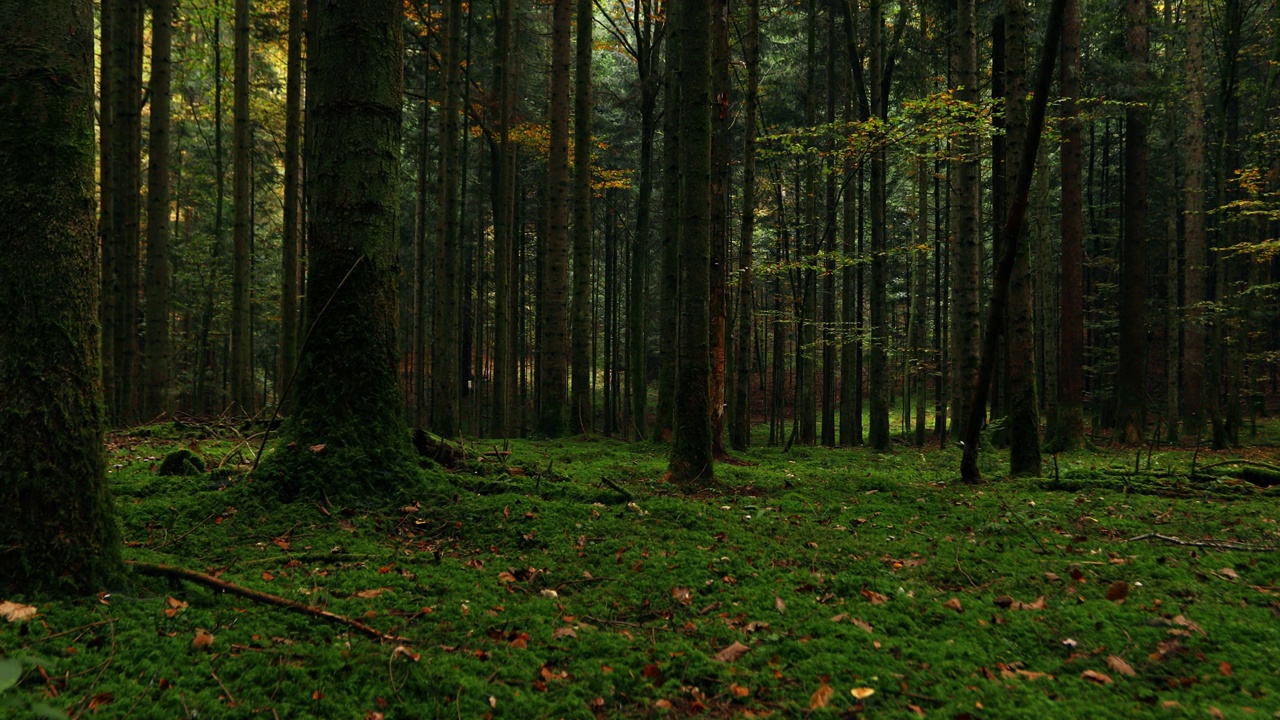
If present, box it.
[230,0,255,415]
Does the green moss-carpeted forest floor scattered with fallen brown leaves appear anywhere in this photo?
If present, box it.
[0,423,1280,719]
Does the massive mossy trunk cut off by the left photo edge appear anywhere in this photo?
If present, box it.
[0,0,122,593]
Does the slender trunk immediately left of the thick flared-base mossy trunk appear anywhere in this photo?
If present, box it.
[278,0,305,410]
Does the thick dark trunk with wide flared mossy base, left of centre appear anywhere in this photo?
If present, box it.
[262,0,415,498]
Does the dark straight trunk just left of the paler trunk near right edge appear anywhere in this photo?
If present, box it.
[1116,0,1147,443]
